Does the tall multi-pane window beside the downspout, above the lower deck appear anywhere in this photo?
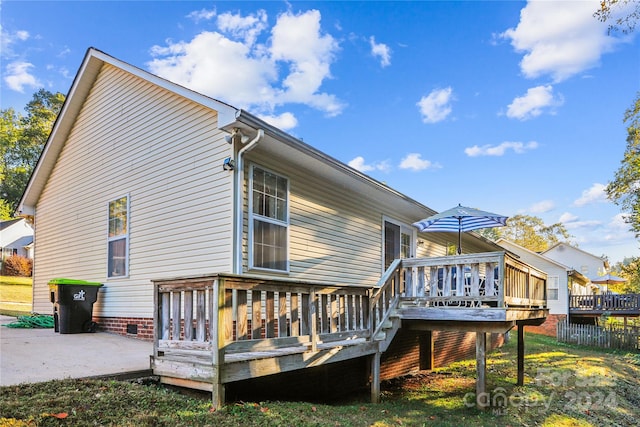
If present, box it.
[249,165,289,271]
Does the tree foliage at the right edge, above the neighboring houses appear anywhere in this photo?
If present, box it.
[606,93,640,237]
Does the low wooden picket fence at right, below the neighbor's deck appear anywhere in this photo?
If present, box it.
[557,320,640,350]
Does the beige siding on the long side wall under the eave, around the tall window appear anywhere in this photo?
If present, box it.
[244,156,444,285]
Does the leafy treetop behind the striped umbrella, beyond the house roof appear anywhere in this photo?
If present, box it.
[480,215,571,252]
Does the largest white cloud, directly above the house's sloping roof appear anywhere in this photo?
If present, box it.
[147,10,344,125]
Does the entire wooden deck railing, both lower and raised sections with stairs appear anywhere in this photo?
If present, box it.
[154,252,546,365]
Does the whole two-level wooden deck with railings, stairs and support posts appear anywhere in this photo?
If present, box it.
[151,252,547,406]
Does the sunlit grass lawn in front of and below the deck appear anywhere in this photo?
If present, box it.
[0,334,640,427]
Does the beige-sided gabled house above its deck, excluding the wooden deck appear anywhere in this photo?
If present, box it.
[19,49,501,338]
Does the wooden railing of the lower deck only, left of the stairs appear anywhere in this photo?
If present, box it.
[154,275,371,359]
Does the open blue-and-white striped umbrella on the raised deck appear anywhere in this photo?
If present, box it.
[413,205,508,255]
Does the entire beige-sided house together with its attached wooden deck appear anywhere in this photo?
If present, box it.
[18,48,546,404]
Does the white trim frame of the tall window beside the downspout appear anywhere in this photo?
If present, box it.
[247,163,291,274]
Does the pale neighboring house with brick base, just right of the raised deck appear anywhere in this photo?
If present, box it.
[497,239,591,336]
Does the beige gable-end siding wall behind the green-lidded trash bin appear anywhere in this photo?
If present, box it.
[34,65,233,318]
